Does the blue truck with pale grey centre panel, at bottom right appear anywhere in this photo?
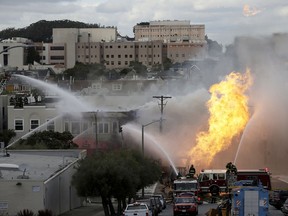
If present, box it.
[231,180,269,216]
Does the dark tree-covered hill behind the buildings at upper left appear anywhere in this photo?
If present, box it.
[0,20,100,43]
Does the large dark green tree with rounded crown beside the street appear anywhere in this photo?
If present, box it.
[72,149,161,216]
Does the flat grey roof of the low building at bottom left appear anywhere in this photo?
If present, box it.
[0,149,83,181]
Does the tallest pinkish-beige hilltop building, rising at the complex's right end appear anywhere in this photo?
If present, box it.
[134,20,206,63]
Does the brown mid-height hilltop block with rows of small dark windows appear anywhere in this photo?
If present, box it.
[76,40,165,69]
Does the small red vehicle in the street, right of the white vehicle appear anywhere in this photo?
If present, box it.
[173,196,198,216]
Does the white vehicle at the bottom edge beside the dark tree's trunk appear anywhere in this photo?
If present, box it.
[123,202,152,216]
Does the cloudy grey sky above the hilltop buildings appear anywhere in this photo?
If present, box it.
[0,0,288,45]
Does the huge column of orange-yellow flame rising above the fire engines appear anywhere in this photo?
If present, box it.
[189,69,252,168]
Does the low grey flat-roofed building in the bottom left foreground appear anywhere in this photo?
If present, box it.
[0,149,87,215]
